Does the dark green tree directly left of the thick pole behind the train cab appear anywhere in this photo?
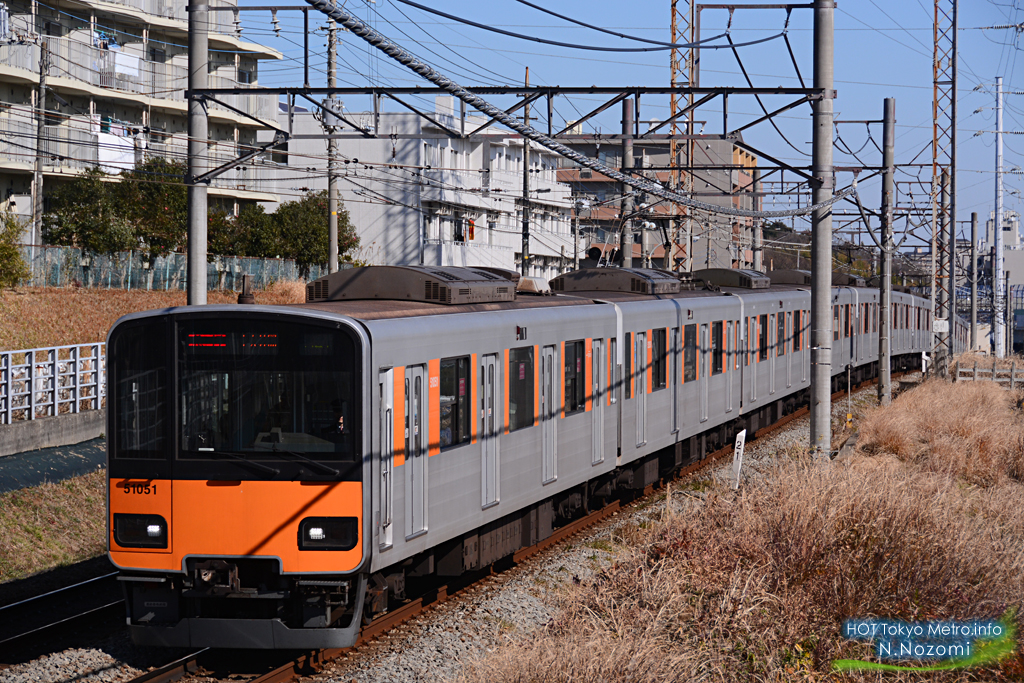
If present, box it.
[112,157,188,255]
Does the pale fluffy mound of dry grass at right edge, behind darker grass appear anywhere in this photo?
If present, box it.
[858,380,1024,485]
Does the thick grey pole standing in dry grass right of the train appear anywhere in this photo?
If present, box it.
[810,0,836,456]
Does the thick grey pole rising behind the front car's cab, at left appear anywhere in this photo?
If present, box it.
[186,0,210,306]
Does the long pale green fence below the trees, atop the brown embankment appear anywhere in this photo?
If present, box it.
[22,246,327,292]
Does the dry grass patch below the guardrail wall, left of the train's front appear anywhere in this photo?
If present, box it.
[0,470,106,582]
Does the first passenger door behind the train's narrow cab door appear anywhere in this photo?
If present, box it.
[403,366,430,539]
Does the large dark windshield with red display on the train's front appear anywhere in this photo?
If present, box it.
[177,318,359,462]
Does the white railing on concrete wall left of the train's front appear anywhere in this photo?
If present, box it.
[0,342,106,425]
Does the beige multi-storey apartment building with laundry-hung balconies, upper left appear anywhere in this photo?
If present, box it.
[0,0,282,242]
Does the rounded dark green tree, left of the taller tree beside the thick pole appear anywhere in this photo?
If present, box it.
[43,168,137,254]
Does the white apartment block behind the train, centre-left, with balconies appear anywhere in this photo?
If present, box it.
[259,96,582,279]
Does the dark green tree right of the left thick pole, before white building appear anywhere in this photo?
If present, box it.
[273,190,359,276]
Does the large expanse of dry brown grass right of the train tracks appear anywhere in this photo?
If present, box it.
[464,381,1024,683]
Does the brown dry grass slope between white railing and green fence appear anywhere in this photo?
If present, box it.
[0,282,305,350]
